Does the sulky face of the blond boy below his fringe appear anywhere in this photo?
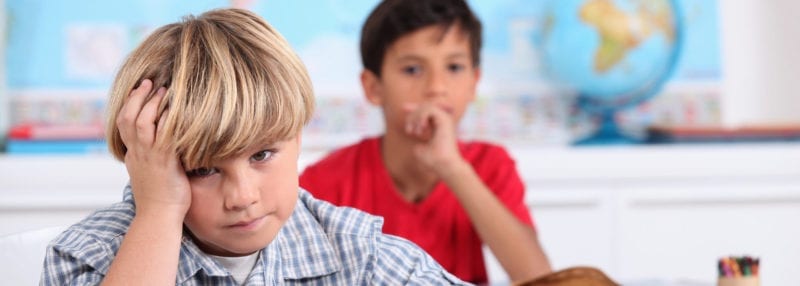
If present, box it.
[184,136,300,256]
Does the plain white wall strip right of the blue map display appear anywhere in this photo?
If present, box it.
[718,0,800,127]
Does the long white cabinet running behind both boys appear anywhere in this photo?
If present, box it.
[0,144,800,285]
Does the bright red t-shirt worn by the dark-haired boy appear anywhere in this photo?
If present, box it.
[300,138,533,283]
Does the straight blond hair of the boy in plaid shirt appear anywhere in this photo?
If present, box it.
[106,9,314,169]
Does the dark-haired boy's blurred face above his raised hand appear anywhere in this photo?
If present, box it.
[364,25,480,138]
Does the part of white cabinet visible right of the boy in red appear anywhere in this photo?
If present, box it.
[504,144,800,285]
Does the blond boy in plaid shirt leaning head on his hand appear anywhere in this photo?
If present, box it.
[41,9,463,285]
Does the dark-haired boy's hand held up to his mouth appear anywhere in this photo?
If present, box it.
[404,103,463,172]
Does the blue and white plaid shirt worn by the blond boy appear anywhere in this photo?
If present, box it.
[40,187,466,285]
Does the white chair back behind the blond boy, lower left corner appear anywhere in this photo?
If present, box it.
[0,226,67,285]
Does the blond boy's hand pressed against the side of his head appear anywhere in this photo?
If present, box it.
[116,79,191,220]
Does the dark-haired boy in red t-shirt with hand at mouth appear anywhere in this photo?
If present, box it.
[300,0,551,283]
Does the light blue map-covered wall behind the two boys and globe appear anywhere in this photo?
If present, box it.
[0,0,724,149]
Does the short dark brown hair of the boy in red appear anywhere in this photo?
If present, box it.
[361,0,482,77]
